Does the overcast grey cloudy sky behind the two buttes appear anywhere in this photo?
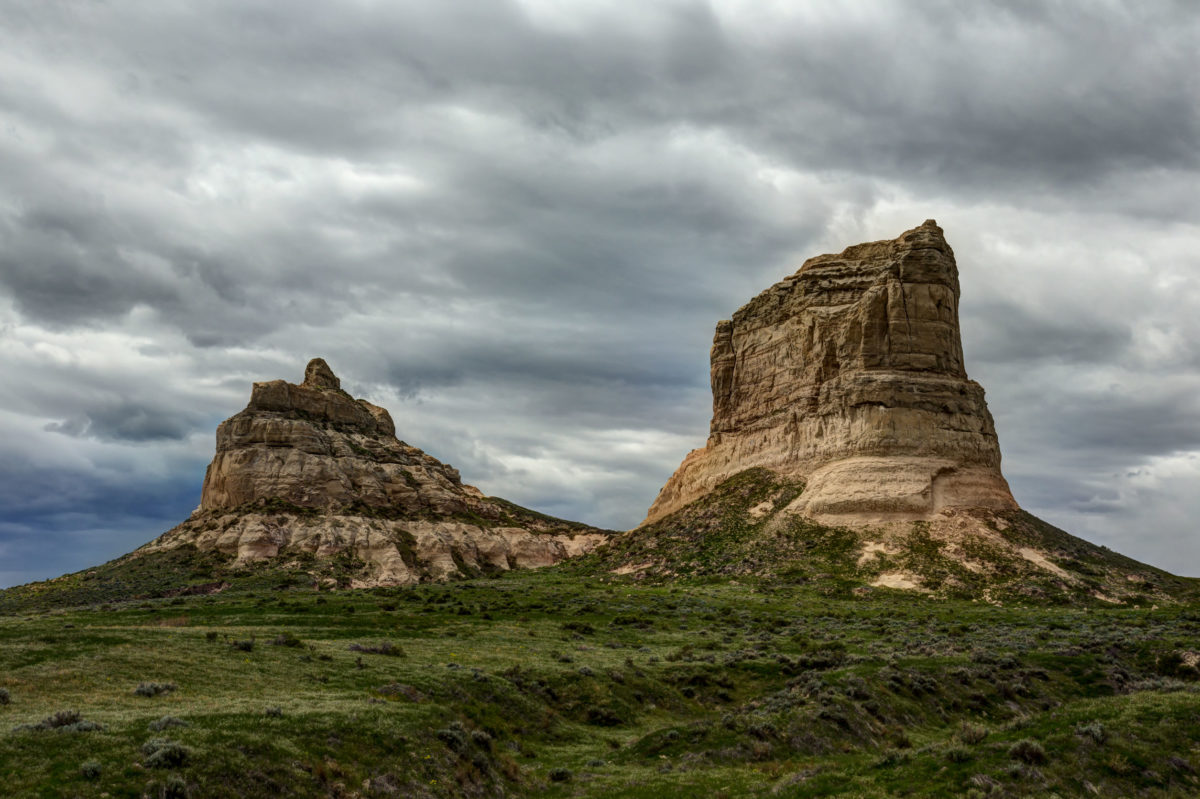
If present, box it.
[0,0,1200,585]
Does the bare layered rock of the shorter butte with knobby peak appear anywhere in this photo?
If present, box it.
[143,359,607,585]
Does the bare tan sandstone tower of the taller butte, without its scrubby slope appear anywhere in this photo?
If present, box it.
[643,220,1016,525]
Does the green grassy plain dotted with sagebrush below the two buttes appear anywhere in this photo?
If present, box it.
[0,552,1200,799]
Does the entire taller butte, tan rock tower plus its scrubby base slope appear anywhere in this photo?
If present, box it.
[624,220,1189,603]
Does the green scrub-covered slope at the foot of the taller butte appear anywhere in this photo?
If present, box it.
[569,469,1200,606]
